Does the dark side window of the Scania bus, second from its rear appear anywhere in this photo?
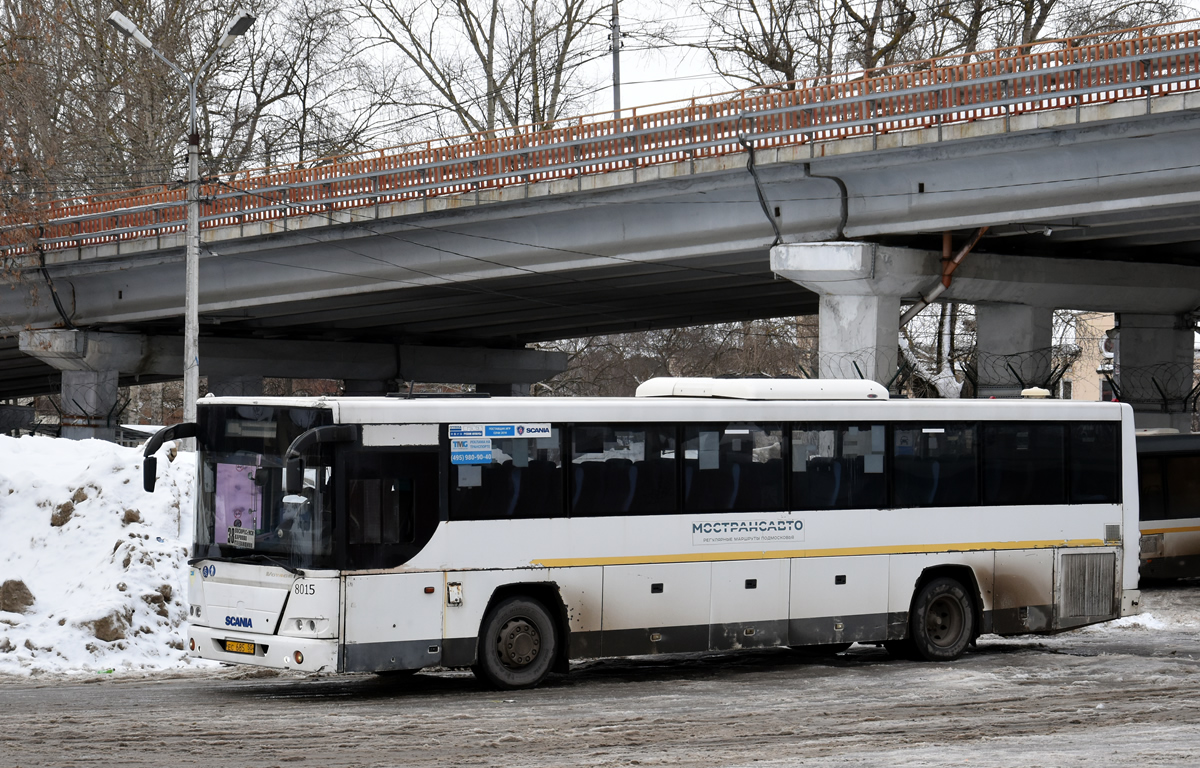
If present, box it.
[982,422,1067,506]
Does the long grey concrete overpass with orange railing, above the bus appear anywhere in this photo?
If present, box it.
[0,25,1200,434]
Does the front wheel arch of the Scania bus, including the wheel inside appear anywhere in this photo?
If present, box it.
[472,582,569,689]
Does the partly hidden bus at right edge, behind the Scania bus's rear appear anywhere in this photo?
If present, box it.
[1138,430,1200,578]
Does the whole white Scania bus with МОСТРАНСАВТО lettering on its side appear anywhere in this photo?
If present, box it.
[145,379,1138,688]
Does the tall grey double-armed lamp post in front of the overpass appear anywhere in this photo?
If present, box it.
[108,8,254,436]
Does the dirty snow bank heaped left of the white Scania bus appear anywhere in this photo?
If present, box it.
[0,436,202,674]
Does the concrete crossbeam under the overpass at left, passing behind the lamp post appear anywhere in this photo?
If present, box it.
[20,330,566,389]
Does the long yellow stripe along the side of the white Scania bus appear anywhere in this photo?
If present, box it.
[529,539,1105,568]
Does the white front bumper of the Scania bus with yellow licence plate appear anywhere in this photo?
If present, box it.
[187,624,337,672]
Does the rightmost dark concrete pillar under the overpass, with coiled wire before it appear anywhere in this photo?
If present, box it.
[1115,312,1195,432]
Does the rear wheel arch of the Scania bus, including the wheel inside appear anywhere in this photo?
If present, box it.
[905,565,983,661]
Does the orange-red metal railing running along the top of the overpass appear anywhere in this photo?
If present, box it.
[0,20,1200,254]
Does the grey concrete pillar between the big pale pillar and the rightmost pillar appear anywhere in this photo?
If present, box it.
[976,304,1054,397]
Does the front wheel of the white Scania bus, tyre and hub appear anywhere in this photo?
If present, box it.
[472,596,558,690]
